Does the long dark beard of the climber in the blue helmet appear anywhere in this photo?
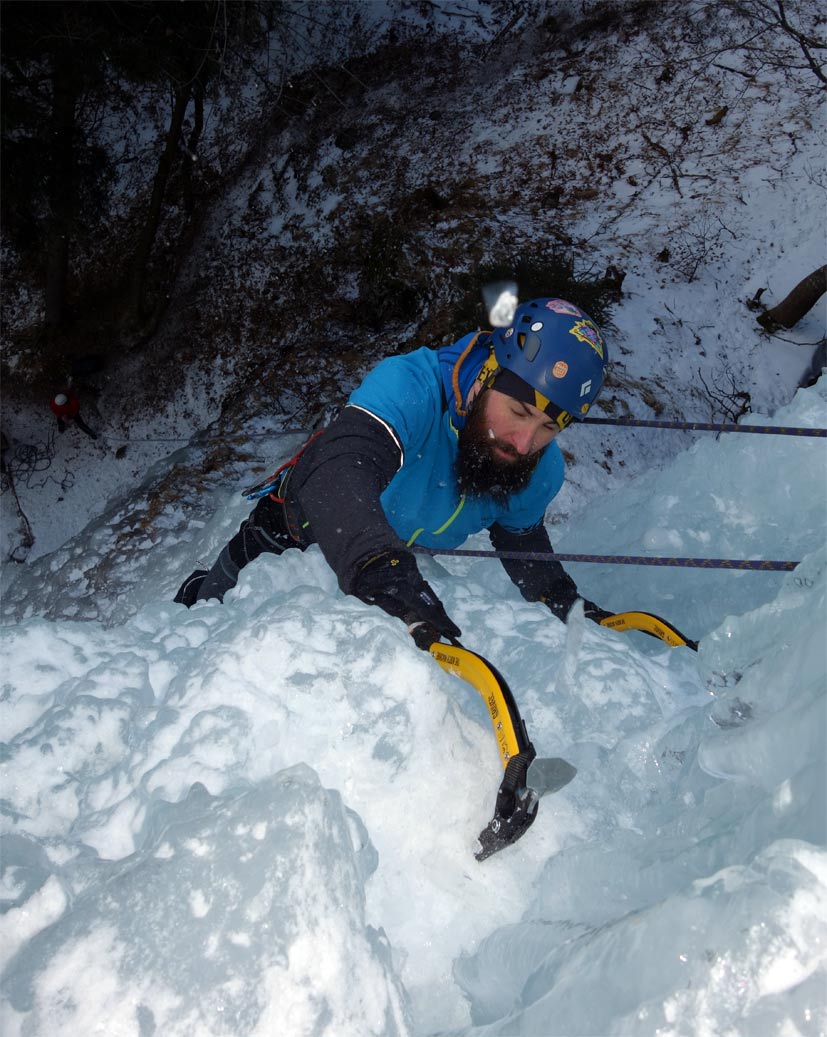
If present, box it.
[457,393,545,507]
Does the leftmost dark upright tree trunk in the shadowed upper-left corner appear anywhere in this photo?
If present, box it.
[44,39,77,330]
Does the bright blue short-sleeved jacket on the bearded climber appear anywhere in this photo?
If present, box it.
[349,334,564,549]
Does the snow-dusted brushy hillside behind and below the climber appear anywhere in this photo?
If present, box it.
[2,3,827,568]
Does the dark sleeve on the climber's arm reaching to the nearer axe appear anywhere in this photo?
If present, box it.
[286,407,408,594]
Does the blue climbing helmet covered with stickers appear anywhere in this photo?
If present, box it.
[489,299,608,428]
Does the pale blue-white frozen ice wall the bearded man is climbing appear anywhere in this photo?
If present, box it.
[0,380,827,1037]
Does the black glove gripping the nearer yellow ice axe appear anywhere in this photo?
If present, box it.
[353,551,462,651]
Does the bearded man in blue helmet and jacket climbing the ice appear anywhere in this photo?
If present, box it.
[175,299,611,650]
